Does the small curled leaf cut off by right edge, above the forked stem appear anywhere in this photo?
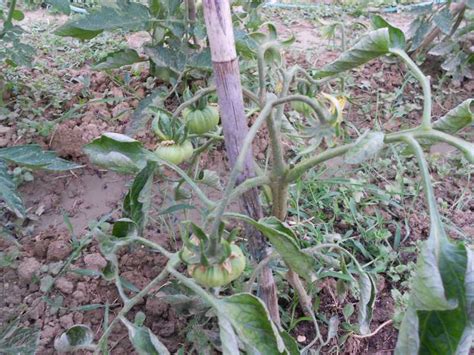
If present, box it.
[433,99,474,134]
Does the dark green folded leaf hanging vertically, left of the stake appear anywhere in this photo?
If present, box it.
[123,161,156,234]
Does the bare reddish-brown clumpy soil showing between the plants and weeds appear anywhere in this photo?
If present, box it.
[0,5,474,355]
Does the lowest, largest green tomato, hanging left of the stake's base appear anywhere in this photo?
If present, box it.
[188,244,245,287]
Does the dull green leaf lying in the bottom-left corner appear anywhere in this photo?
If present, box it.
[0,317,40,355]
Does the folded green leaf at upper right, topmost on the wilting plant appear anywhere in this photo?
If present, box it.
[315,27,401,78]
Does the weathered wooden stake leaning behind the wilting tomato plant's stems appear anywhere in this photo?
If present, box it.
[203,0,279,324]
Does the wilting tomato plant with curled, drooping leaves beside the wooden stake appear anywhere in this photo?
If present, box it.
[49,4,474,354]
